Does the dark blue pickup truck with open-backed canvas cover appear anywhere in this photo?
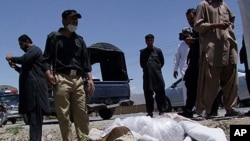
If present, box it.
[87,43,133,119]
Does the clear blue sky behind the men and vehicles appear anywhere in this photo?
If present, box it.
[0,0,243,93]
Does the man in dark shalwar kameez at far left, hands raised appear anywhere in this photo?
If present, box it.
[6,35,49,141]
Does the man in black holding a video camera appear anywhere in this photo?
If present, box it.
[178,8,199,118]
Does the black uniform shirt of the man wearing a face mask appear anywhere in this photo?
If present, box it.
[43,28,91,72]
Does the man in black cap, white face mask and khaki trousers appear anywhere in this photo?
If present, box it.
[43,10,94,141]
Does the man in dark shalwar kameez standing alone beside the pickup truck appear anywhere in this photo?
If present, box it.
[140,34,166,117]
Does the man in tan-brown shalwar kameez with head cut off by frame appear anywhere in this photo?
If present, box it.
[194,0,242,116]
